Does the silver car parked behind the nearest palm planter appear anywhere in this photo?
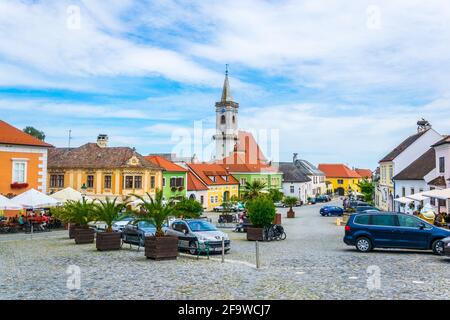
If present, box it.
[166,219,231,254]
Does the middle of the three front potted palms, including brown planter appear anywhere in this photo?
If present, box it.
[94,197,128,251]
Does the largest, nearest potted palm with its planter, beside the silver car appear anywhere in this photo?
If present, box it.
[134,190,178,260]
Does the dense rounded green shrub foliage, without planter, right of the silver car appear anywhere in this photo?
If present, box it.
[246,196,276,228]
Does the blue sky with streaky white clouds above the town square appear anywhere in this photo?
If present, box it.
[0,0,450,169]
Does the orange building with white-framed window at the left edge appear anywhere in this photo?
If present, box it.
[0,120,53,197]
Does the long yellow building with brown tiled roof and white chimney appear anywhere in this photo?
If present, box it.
[48,135,162,199]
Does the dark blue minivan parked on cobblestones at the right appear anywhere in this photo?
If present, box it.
[344,212,450,254]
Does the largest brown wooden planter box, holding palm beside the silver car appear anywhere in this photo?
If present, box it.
[145,236,178,260]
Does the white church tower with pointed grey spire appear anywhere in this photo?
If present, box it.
[213,65,239,160]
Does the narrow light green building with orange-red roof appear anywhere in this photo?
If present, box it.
[145,155,188,200]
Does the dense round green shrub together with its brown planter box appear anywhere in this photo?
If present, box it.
[246,196,276,241]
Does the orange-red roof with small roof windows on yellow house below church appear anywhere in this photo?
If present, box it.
[188,163,239,186]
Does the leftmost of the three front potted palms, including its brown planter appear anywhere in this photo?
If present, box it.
[64,199,95,244]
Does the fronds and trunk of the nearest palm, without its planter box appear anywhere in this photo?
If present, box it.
[134,190,175,237]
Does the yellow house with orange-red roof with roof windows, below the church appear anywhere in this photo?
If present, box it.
[187,163,239,210]
